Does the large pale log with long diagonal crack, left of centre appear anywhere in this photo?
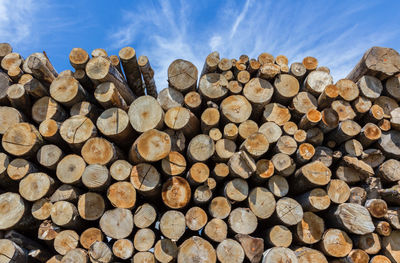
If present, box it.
[60,115,97,150]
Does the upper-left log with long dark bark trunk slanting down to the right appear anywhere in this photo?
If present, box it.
[86,57,135,104]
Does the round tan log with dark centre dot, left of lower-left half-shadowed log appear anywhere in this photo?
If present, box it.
[56,154,86,184]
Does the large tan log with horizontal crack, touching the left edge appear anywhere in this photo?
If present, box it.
[1,122,43,157]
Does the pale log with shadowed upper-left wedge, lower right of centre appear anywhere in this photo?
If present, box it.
[248,187,276,220]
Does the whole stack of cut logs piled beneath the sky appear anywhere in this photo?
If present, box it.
[0,43,400,263]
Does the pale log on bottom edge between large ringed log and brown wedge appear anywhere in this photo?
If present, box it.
[216,238,245,263]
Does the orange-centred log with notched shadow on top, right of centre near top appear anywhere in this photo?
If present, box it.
[243,78,276,119]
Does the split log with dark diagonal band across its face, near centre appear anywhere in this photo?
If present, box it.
[228,151,257,179]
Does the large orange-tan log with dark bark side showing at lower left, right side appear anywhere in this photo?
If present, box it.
[293,161,332,192]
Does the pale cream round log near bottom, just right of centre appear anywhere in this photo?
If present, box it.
[228,207,258,234]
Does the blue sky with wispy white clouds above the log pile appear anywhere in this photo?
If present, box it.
[0,0,400,89]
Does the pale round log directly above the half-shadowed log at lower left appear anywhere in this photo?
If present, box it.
[82,164,111,191]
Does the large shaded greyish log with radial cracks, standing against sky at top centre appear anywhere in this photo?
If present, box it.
[168,59,198,94]
